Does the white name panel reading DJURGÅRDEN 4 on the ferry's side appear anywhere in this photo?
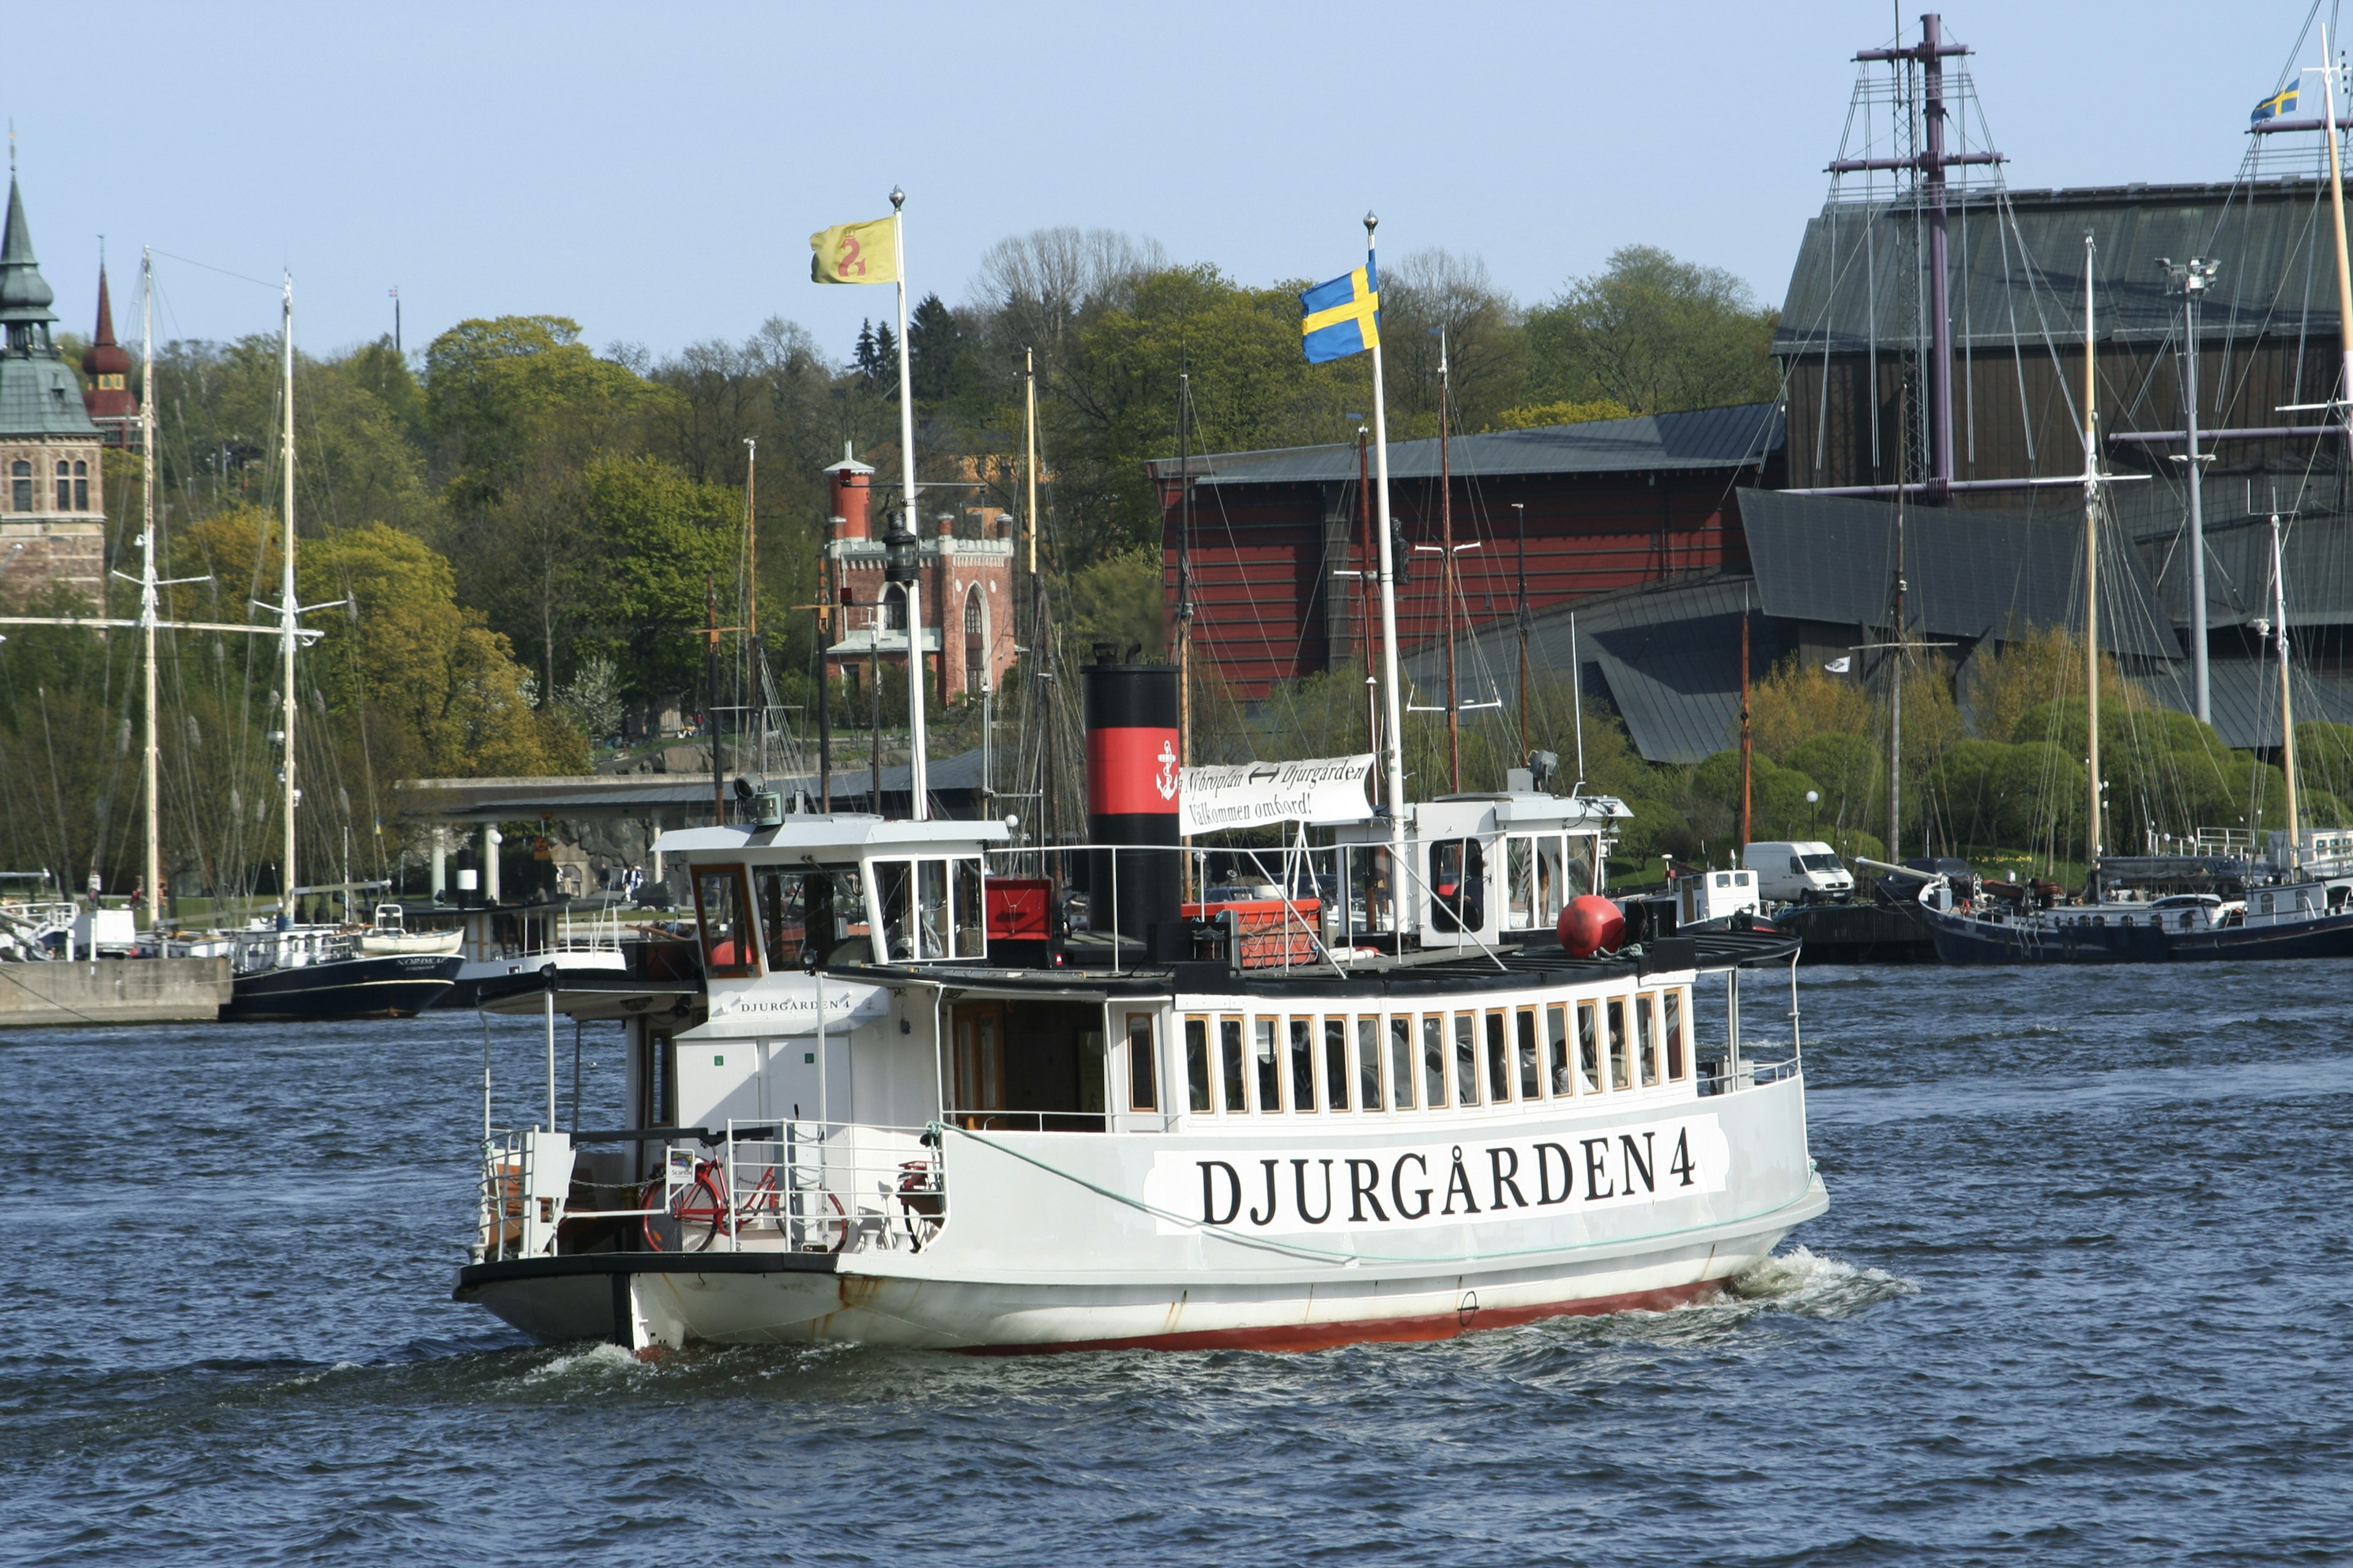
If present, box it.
[1143,1116,1732,1236]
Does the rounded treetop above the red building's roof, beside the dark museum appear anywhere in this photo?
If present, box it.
[1527,245,1781,414]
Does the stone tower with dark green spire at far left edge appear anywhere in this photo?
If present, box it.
[0,172,106,605]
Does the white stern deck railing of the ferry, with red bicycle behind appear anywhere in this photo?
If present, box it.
[473,1118,949,1262]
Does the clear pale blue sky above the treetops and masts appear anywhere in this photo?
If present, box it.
[0,0,2336,358]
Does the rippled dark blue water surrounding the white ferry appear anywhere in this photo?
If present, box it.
[0,963,2353,1568]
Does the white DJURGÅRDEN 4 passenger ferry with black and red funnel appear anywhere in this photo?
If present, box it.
[457,666,1826,1352]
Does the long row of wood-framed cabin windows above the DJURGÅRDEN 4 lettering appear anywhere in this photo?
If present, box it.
[1162,987,1692,1116]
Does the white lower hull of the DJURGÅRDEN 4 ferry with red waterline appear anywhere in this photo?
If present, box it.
[457,1078,1828,1354]
